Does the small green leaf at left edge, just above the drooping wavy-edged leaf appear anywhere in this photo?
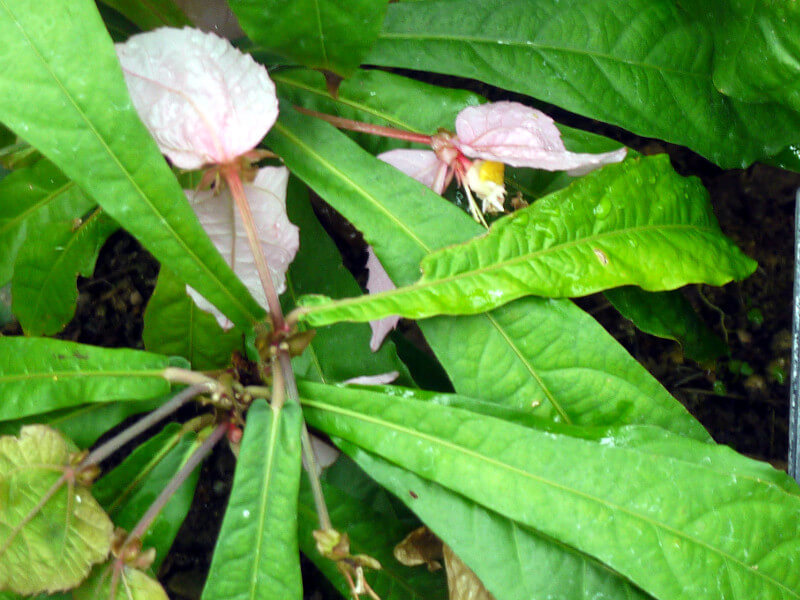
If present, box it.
[0,160,93,284]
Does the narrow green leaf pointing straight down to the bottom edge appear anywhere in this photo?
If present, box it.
[202,400,303,600]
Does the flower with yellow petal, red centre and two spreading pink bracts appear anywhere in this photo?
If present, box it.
[378,102,627,225]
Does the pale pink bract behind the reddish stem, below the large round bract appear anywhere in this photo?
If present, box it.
[186,167,300,329]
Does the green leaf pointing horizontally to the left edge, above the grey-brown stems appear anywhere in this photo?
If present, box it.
[0,337,170,420]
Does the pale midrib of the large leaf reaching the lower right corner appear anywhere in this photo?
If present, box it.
[301,398,800,598]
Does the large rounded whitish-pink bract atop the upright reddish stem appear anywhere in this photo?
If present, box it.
[116,27,278,169]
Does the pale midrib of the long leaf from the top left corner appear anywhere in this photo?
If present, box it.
[0,0,258,323]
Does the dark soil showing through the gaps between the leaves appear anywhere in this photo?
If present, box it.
[3,103,800,599]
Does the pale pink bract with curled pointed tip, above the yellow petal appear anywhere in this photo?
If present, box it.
[454,102,627,175]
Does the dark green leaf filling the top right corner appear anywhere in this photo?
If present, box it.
[686,0,800,111]
